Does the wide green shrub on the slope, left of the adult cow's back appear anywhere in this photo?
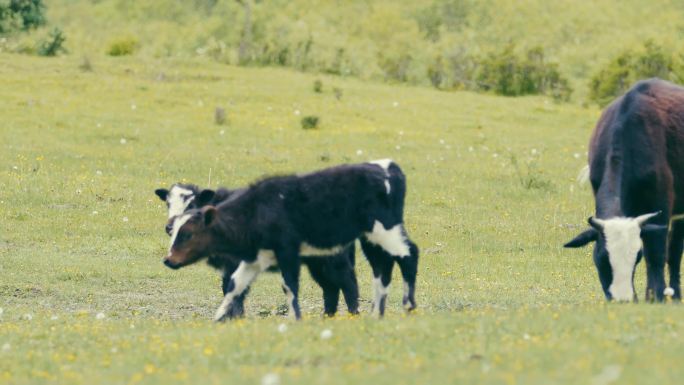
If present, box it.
[475,44,572,100]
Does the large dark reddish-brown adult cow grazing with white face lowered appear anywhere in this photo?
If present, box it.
[565,79,684,301]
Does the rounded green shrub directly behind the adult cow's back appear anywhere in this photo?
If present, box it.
[589,40,678,106]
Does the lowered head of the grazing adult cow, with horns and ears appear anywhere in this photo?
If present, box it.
[564,212,667,301]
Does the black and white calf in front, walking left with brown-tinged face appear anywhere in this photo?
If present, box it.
[164,160,418,321]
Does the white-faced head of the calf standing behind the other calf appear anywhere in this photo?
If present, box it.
[154,184,215,235]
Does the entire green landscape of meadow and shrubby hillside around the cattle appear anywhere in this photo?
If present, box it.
[0,0,684,385]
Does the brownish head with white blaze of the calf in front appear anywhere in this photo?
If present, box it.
[164,206,217,269]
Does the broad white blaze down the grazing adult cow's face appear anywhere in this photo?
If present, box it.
[602,218,643,301]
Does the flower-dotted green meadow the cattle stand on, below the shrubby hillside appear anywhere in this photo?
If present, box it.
[0,54,684,384]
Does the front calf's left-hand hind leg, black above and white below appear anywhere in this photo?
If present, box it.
[360,237,394,317]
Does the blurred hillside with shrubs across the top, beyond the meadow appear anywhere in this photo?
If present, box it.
[0,0,684,105]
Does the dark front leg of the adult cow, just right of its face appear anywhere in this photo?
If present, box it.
[642,226,667,302]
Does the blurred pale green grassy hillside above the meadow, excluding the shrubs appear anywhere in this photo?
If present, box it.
[0,0,684,101]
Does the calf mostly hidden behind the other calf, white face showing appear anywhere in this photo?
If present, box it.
[155,184,359,317]
